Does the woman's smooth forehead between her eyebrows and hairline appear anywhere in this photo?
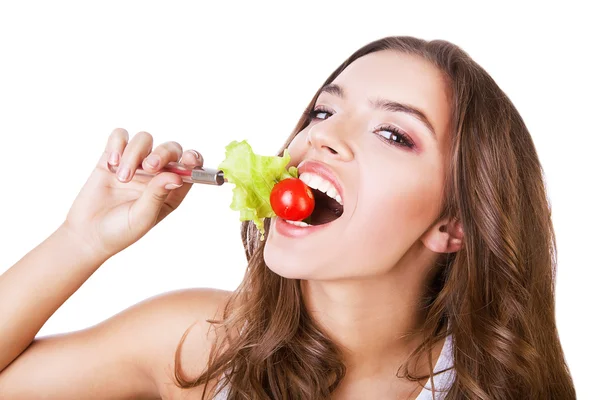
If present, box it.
[333,50,450,136]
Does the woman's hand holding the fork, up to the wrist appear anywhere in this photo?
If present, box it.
[61,129,203,259]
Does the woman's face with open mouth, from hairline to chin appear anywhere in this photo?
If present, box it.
[264,50,450,280]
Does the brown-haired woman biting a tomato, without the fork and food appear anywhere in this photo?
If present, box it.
[0,37,575,400]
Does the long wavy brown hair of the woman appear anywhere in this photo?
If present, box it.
[175,36,575,400]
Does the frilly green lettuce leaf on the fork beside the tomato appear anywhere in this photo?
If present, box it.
[218,140,298,240]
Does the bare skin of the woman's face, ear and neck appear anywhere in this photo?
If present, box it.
[265,51,462,398]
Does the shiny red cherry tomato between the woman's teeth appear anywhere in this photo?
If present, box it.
[270,178,315,221]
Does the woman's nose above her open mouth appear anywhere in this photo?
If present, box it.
[306,120,354,161]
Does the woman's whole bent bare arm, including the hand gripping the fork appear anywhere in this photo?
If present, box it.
[0,129,215,399]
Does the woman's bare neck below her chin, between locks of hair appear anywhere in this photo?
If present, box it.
[301,247,435,378]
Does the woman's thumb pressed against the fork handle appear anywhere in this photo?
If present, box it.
[131,172,183,229]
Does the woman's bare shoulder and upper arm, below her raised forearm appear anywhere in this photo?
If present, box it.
[0,288,231,400]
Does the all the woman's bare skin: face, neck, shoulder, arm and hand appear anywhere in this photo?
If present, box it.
[0,52,462,400]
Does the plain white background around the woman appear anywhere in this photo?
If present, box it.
[0,1,600,399]
